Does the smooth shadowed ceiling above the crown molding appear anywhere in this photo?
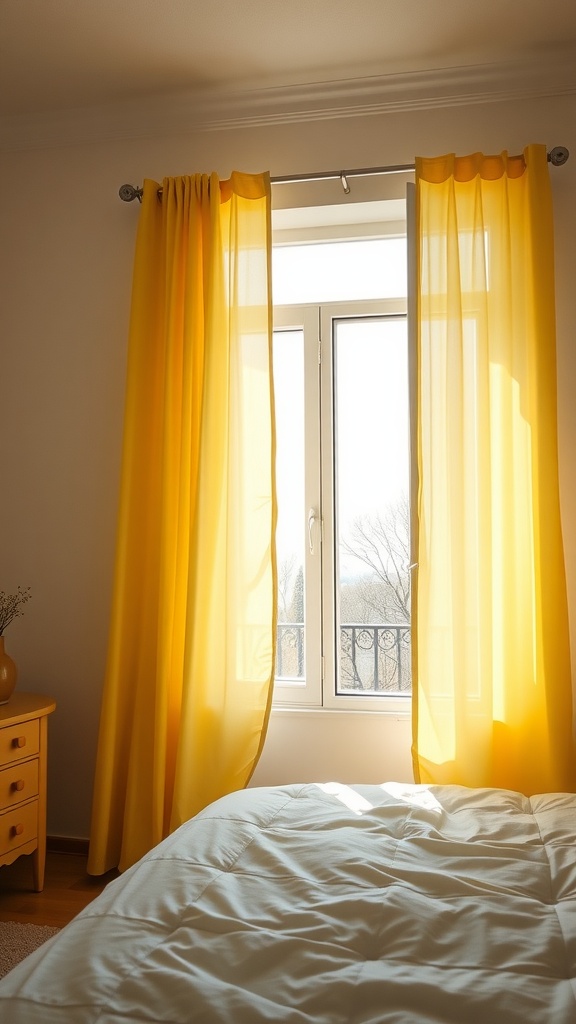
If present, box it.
[0,0,576,117]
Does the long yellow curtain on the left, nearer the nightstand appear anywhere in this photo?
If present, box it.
[88,173,276,874]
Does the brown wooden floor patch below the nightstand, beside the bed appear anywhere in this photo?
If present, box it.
[0,852,118,928]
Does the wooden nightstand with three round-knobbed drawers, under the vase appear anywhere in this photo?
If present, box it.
[0,692,56,892]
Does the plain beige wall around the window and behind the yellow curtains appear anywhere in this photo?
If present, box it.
[0,88,576,837]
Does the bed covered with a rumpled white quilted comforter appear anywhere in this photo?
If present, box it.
[0,783,576,1024]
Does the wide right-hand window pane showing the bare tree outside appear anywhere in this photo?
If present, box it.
[333,316,411,695]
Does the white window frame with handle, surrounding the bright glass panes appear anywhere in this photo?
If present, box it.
[273,193,417,717]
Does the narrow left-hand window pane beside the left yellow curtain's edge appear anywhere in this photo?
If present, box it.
[274,330,305,683]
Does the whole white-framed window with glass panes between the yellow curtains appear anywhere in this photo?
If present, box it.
[273,195,411,710]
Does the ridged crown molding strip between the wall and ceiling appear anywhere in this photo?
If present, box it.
[0,50,576,152]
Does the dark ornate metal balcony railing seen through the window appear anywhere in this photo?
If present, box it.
[276,623,412,694]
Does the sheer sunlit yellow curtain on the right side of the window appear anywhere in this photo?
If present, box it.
[413,145,575,795]
